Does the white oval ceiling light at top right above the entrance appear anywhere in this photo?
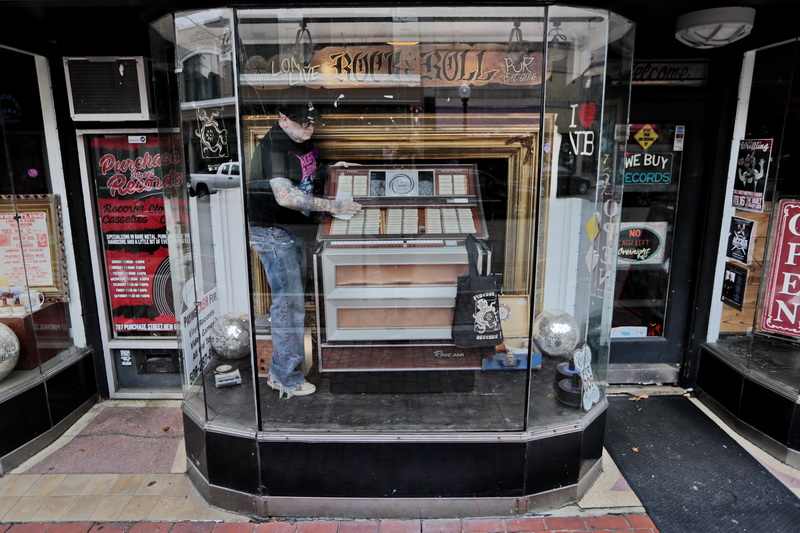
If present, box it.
[675,7,756,48]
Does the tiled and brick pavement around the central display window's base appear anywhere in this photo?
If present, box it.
[0,386,800,533]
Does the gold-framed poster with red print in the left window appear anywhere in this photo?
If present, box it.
[0,194,69,301]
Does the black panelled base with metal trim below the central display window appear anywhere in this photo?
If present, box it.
[184,402,607,518]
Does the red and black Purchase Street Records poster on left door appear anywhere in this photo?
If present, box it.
[89,135,184,337]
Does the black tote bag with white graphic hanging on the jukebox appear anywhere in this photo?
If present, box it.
[453,235,503,348]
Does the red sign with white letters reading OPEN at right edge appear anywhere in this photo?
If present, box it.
[761,200,800,337]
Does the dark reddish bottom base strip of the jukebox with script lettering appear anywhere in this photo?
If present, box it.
[320,344,482,372]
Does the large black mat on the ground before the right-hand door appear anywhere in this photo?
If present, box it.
[605,396,800,533]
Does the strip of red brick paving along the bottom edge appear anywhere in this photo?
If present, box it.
[0,514,658,533]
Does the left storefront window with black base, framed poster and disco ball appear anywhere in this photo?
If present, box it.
[0,43,95,464]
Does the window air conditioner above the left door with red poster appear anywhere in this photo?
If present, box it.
[64,56,155,122]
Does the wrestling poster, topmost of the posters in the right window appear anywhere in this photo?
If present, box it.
[733,139,772,213]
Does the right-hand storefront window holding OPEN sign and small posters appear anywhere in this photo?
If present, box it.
[709,41,800,392]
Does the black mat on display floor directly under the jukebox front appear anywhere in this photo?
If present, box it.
[330,370,475,394]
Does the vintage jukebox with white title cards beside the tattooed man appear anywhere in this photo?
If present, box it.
[315,165,491,371]
